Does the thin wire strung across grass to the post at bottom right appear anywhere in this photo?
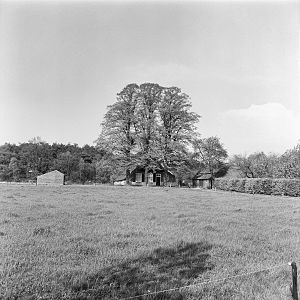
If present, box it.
[118,262,300,300]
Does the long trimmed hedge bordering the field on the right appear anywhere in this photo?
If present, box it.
[215,178,300,197]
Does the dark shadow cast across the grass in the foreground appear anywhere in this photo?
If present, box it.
[72,242,214,299]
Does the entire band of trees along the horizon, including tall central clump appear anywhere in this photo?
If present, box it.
[0,83,300,183]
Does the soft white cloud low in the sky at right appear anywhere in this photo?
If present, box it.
[218,103,300,154]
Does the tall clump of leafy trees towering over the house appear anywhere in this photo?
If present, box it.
[97,83,200,181]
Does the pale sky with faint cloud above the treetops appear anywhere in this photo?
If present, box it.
[0,0,300,155]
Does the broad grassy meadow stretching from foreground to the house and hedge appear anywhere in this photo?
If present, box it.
[0,184,300,299]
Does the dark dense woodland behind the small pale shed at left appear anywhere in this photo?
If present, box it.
[0,138,104,183]
